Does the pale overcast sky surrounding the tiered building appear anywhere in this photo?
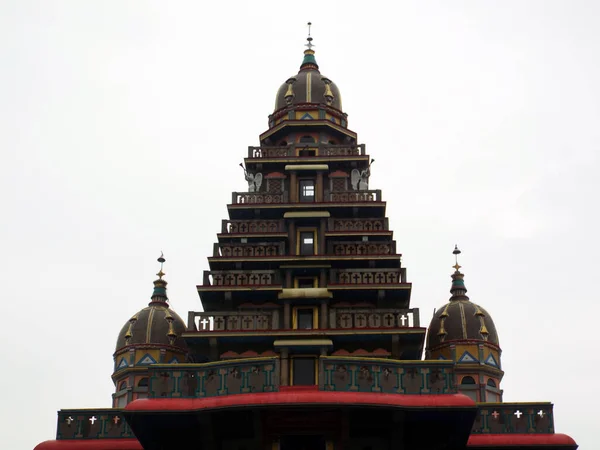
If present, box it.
[0,0,600,450]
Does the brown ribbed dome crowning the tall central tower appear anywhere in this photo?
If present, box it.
[275,49,342,112]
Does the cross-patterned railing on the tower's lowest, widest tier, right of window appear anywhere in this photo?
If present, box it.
[329,307,420,329]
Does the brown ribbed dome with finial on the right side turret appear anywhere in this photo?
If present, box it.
[427,266,500,350]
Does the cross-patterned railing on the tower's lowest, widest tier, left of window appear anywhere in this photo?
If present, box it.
[188,310,279,331]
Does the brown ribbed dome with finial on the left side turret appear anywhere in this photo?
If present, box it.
[116,277,186,351]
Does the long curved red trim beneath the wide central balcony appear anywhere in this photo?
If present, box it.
[125,389,475,412]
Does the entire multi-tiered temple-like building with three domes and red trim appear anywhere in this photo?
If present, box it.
[36,38,577,450]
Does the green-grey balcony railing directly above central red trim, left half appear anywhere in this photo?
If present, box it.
[148,358,280,398]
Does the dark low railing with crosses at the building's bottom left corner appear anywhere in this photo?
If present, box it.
[56,408,135,439]
